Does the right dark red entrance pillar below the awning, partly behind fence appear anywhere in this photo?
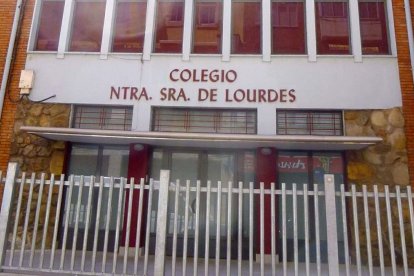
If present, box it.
[256,148,277,254]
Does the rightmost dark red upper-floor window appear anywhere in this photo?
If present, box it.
[359,0,389,55]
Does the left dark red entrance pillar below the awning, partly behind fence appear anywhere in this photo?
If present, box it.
[121,144,150,247]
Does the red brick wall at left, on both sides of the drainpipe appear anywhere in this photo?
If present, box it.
[0,0,34,177]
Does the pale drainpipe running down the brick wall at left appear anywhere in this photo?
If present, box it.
[0,0,22,119]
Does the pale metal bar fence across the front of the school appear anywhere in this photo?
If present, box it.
[0,163,414,275]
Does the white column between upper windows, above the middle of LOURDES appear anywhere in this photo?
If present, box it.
[262,0,272,61]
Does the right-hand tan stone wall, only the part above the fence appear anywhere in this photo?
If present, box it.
[345,108,410,186]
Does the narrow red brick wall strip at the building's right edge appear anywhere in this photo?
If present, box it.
[393,0,414,186]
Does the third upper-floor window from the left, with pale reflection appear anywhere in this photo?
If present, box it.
[112,0,147,53]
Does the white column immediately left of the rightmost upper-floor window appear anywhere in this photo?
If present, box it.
[349,0,362,62]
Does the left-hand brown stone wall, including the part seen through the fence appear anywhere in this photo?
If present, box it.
[10,100,70,248]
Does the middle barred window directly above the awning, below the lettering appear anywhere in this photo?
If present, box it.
[152,107,257,134]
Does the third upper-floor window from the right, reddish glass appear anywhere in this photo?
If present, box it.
[272,0,306,54]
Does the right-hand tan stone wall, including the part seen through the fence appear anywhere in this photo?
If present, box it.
[345,108,414,267]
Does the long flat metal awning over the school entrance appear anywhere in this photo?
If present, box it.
[20,126,382,150]
